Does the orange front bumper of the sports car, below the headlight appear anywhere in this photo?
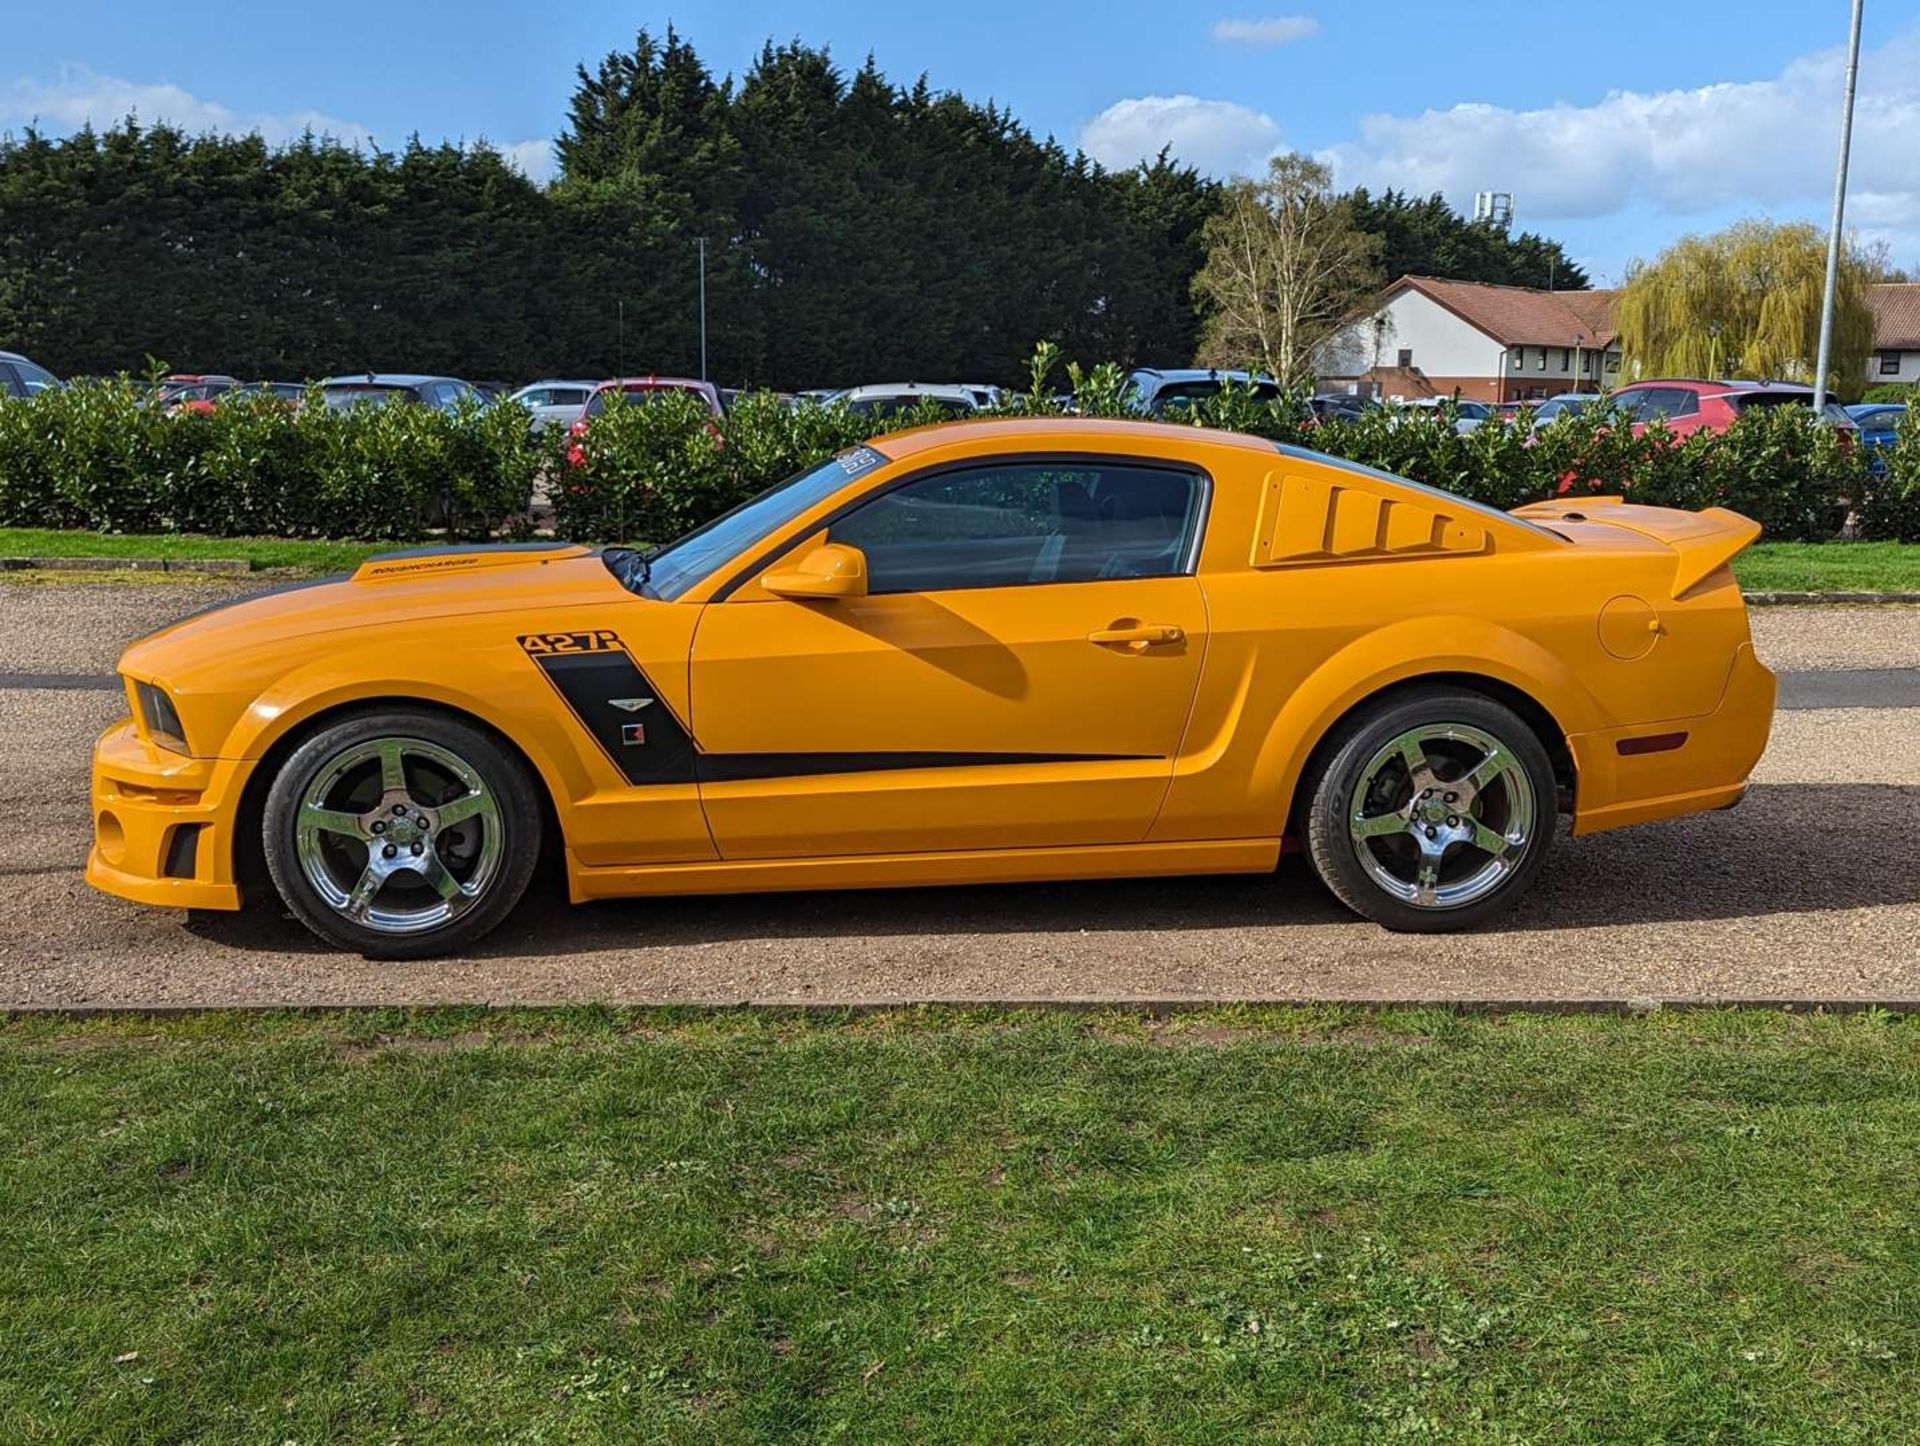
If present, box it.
[86,718,246,908]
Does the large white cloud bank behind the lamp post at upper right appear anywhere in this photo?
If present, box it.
[1321,31,1920,223]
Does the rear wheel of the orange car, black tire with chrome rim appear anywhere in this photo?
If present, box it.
[1302,687,1559,933]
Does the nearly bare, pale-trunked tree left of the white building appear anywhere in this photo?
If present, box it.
[1192,156,1380,384]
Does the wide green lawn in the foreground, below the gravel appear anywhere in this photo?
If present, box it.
[0,1010,1920,1442]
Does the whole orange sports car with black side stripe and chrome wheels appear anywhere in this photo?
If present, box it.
[86,419,1774,958]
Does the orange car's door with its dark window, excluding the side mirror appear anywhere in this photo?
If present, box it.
[691,459,1210,858]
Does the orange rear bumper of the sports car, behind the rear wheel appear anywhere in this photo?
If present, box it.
[1567,643,1778,833]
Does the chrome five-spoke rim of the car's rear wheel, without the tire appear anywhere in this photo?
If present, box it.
[1348,722,1534,908]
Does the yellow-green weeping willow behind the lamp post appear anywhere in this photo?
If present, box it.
[1615,221,1874,396]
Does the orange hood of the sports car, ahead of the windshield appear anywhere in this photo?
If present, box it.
[119,542,632,680]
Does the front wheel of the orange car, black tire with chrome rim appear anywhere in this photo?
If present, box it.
[261,709,541,960]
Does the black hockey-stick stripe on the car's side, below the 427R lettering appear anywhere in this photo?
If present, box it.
[528,647,1156,783]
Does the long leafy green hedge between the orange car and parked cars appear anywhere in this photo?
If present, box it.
[0,366,1920,542]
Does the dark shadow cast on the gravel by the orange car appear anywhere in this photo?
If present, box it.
[188,783,1920,958]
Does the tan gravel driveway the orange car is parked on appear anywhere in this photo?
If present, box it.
[0,584,1920,1006]
